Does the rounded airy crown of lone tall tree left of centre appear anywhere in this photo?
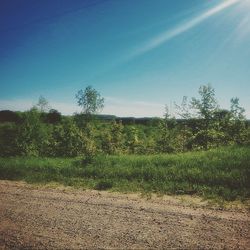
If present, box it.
[76,86,104,118]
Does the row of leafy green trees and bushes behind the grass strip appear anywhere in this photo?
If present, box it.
[0,85,250,160]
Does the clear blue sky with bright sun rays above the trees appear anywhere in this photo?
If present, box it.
[0,0,250,118]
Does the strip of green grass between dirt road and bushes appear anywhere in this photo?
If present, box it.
[0,147,250,200]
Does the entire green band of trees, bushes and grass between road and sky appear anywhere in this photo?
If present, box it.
[0,85,250,200]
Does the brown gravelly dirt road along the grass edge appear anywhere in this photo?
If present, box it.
[0,181,250,249]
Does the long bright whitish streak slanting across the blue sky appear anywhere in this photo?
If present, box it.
[127,0,240,59]
